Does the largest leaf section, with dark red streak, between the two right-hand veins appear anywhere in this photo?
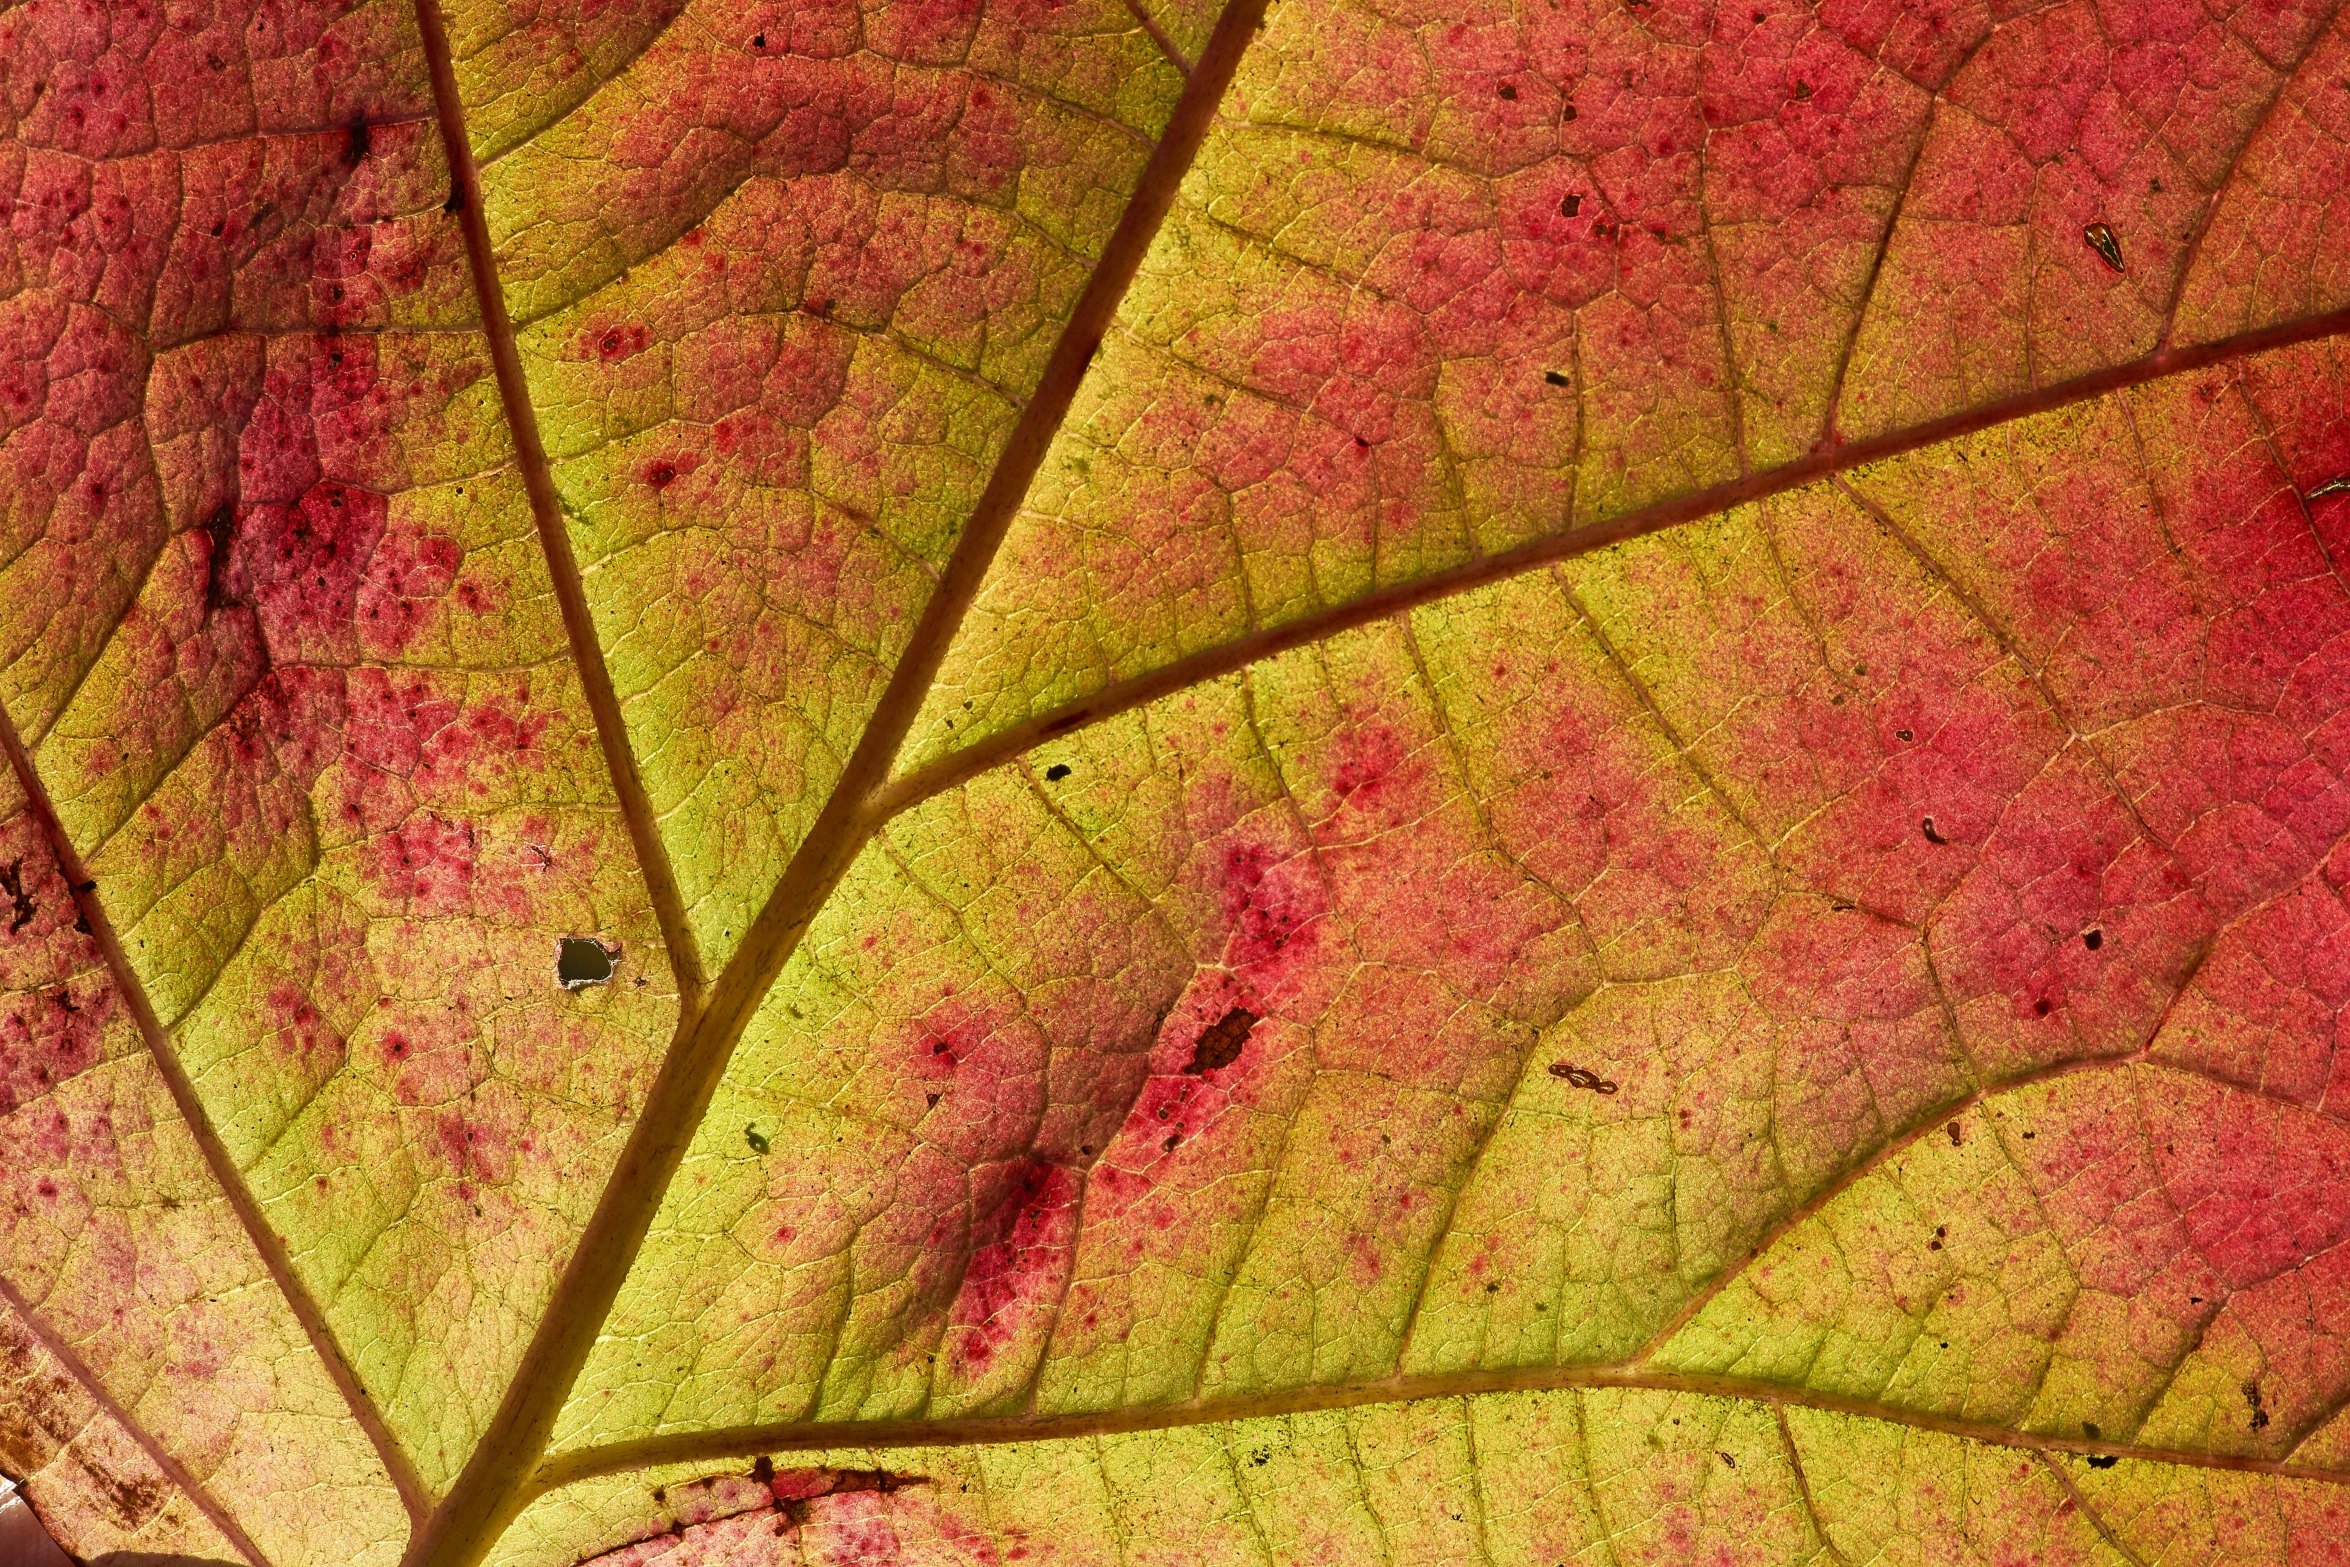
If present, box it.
[559,343,2350,1457]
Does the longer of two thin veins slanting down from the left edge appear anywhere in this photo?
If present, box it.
[0,707,425,1520]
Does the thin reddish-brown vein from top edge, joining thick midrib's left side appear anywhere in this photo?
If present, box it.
[416,0,707,1013]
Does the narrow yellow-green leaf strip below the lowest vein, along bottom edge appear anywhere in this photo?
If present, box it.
[491,1388,2350,1567]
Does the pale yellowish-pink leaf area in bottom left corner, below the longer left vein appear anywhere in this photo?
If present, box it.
[0,768,407,1567]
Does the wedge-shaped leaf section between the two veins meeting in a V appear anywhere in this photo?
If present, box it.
[458,0,1182,970]
